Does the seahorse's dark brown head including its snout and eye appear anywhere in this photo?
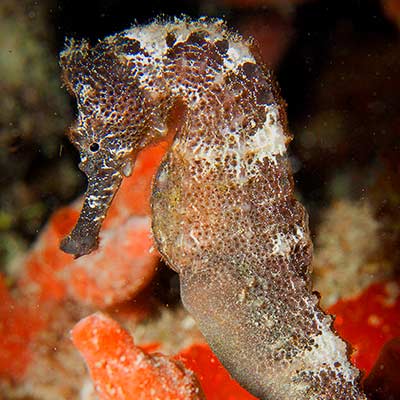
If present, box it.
[60,35,168,256]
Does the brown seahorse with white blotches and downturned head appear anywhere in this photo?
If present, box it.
[60,18,366,400]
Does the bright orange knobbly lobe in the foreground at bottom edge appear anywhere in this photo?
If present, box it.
[72,313,203,400]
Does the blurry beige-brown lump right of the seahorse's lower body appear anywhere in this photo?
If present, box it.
[313,200,394,307]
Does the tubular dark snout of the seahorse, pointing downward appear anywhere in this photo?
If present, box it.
[60,170,122,257]
